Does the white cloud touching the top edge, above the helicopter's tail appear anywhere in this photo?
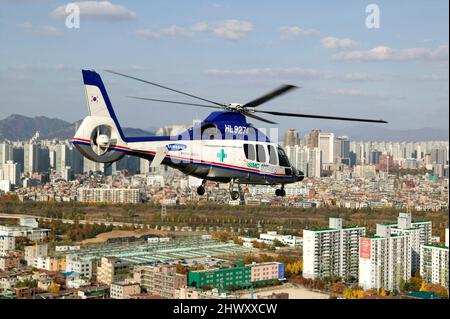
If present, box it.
[50,1,136,21]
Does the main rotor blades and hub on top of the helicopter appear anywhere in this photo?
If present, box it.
[105,70,387,124]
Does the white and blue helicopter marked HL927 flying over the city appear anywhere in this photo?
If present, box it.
[71,70,387,200]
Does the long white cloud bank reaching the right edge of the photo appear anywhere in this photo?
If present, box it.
[333,45,448,62]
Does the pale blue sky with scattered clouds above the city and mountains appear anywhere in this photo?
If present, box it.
[0,0,449,131]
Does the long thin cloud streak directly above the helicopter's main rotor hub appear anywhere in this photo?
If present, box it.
[204,67,333,79]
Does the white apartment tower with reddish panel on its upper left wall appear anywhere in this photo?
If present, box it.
[359,224,411,291]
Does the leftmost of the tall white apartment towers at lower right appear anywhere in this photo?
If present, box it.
[303,218,366,280]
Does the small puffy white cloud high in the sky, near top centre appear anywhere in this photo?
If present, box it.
[191,19,255,40]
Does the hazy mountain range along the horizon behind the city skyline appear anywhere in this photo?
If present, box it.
[0,114,449,142]
